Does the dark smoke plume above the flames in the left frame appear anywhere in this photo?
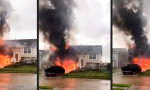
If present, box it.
[0,0,12,56]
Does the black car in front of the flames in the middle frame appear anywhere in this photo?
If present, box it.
[45,66,65,77]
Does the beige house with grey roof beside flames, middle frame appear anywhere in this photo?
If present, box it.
[71,45,102,69]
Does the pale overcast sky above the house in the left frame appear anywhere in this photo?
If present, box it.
[4,0,37,39]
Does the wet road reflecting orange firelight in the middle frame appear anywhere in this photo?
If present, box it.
[39,75,110,90]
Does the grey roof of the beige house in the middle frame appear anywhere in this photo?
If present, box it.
[70,45,102,53]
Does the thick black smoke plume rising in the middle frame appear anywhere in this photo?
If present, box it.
[39,0,78,63]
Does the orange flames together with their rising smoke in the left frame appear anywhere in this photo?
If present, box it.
[0,0,13,68]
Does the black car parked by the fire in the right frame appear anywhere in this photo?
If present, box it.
[121,64,142,75]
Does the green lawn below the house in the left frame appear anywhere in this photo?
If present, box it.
[0,64,37,74]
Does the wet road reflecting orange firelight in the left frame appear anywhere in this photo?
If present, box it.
[0,73,37,90]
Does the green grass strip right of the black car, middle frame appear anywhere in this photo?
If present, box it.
[63,70,110,80]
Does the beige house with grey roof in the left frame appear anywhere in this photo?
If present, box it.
[5,39,37,64]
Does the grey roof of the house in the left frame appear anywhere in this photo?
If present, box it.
[5,39,37,47]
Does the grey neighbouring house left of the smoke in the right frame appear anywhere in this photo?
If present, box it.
[112,48,129,67]
